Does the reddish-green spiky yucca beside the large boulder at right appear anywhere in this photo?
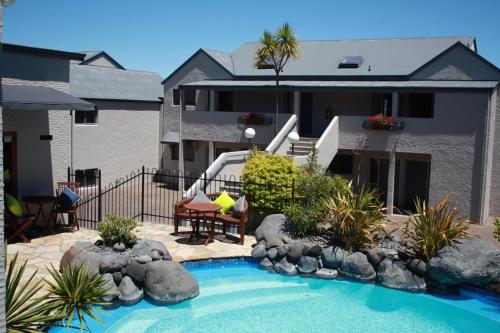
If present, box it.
[403,195,467,262]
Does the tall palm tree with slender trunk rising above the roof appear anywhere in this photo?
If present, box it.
[254,22,300,135]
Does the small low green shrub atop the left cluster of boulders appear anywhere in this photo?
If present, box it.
[97,214,138,247]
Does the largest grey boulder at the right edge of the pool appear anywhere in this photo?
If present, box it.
[427,238,500,286]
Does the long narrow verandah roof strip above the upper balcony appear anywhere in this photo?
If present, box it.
[182,80,498,89]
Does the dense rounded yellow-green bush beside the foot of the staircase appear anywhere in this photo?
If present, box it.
[242,150,297,213]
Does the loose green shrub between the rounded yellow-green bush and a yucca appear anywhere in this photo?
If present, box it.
[284,149,349,237]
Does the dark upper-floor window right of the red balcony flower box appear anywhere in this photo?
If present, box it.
[398,93,434,118]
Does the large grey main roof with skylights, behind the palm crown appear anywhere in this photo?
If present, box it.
[203,36,476,76]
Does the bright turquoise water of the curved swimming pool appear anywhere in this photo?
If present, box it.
[51,260,500,333]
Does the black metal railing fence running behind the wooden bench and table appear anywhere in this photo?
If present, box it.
[64,166,294,229]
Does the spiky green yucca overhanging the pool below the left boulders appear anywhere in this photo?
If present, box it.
[46,263,113,331]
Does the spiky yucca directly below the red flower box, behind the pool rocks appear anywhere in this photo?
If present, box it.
[326,184,384,251]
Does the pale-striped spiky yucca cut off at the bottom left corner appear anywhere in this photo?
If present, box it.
[5,254,61,333]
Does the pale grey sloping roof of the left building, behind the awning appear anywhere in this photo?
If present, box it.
[70,64,163,102]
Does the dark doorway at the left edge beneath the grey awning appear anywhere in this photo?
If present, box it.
[3,131,17,197]
